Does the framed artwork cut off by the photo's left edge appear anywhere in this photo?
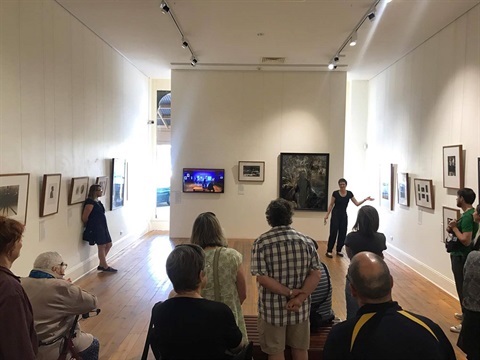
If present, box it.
[0,174,30,225]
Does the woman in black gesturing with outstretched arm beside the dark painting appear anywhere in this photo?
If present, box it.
[324,178,373,258]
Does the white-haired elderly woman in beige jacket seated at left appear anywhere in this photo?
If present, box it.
[21,252,100,360]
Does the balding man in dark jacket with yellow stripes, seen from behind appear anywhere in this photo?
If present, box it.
[323,251,455,360]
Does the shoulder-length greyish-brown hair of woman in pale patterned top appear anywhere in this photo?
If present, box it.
[190,212,227,249]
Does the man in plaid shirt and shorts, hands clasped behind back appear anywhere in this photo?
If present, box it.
[251,199,321,360]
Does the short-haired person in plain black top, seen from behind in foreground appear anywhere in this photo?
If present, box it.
[150,244,242,360]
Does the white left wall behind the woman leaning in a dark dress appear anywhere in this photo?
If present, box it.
[0,0,155,277]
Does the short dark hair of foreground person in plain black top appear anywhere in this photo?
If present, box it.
[166,244,205,293]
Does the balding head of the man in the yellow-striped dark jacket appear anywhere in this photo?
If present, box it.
[347,252,391,299]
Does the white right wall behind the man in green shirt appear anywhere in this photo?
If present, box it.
[346,6,480,295]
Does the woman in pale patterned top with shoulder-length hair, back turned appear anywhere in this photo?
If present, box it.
[190,212,247,344]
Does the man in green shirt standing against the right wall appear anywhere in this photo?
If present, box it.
[447,188,478,333]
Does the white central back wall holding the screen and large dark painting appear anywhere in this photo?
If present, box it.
[170,70,346,240]
